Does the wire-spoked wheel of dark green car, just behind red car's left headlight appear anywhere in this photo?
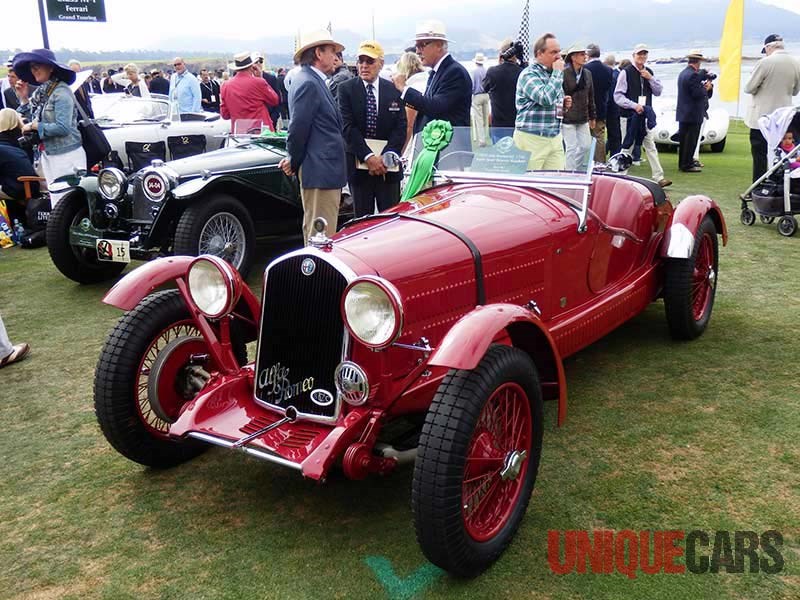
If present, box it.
[174,194,256,277]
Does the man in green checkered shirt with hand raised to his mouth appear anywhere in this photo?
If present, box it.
[514,33,572,171]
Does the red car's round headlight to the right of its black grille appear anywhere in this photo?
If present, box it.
[342,277,403,348]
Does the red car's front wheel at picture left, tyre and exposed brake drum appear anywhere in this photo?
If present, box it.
[94,290,247,468]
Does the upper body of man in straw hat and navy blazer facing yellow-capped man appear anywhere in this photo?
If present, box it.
[394,21,472,135]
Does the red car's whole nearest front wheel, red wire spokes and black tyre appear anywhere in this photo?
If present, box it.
[411,346,543,577]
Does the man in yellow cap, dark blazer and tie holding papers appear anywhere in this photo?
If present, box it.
[338,40,406,217]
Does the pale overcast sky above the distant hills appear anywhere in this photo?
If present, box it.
[6,0,800,50]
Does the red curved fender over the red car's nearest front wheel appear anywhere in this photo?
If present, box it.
[428,304,567,426]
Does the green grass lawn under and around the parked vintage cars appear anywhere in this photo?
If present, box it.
[0,119,800,600]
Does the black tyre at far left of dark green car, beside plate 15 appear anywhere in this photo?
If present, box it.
[46,191,127,284]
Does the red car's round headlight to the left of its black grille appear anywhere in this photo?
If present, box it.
[188,255,241,319]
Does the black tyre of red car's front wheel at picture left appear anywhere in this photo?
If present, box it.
[94,290,246,468]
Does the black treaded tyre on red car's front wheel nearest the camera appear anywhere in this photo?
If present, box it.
[411,345,543,577]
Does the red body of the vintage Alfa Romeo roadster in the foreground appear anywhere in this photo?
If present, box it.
[98,165,727,574]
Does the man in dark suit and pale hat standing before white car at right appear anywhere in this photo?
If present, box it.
[675,50,713,173]
